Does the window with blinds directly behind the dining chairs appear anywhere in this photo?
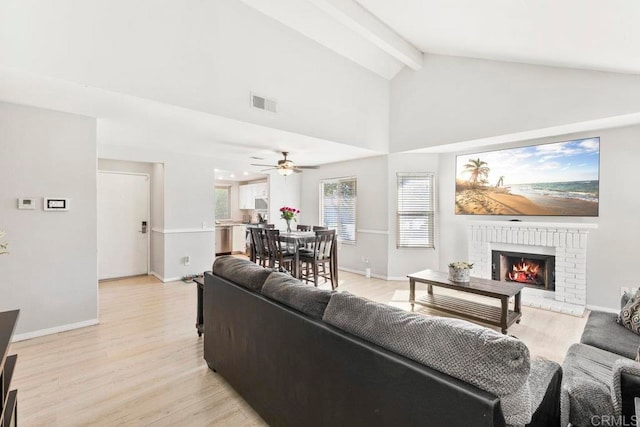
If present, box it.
[320,177,356,243]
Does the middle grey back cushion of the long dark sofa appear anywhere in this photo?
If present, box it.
[262,273,333,319]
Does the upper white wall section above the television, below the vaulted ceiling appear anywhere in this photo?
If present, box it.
[390,54,640,152]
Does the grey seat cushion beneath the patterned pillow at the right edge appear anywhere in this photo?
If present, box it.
[580,311,640,359]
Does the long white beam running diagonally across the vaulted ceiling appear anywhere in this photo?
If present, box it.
[309,0,422,70]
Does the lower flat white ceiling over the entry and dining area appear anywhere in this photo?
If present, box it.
[0,68,380,168]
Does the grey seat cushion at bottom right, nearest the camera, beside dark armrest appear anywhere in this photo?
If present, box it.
[560,344,621,426]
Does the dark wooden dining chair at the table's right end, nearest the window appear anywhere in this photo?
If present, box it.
[299,230,336,289]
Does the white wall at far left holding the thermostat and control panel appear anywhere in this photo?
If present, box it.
[0,103,98,338]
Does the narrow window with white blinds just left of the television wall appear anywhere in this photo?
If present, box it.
[396,173,435,248]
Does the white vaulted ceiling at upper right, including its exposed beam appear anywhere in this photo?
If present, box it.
[248,0,640,78]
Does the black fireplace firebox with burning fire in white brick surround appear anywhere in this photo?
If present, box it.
[491,251,556,291]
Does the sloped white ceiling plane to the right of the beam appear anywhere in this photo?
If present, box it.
[357,0,640,73]
